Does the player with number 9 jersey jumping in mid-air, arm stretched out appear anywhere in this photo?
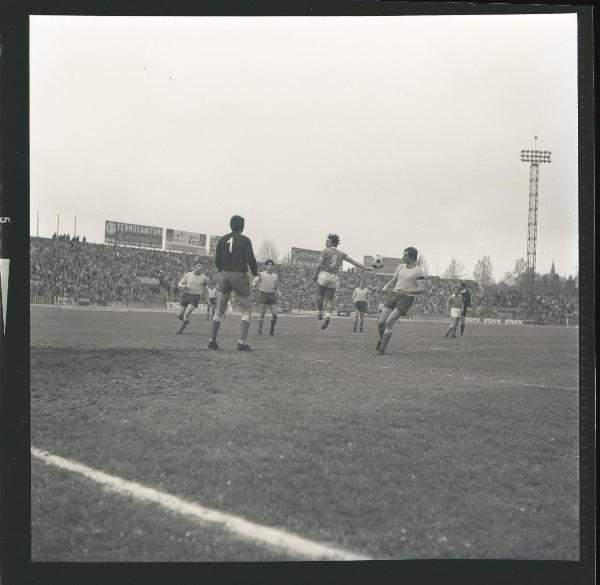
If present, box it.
[313,234,372,329]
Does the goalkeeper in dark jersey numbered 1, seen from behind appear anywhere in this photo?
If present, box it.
[208,215,258,351]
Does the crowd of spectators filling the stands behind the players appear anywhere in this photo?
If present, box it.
[30,234,579,324]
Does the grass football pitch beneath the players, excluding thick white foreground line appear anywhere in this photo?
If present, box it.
[31,307,579,561]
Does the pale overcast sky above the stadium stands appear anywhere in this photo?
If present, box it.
[30,14,578,279]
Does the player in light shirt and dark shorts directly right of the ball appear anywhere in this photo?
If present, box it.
[376,247,425,355]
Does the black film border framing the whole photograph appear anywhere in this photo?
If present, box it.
[0,0,597,585]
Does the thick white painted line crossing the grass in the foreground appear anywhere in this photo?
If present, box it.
[31,447,370,561]
